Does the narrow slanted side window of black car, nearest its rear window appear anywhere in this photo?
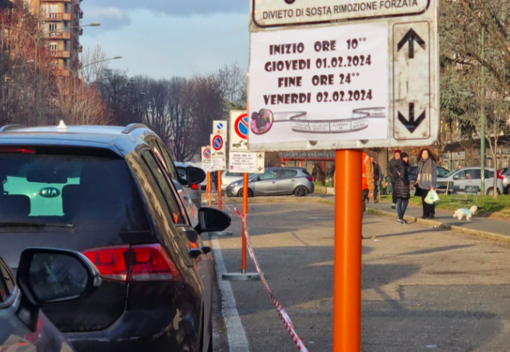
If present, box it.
[142,151,187,225]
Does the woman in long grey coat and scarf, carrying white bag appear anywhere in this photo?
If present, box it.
[416,149,437,219]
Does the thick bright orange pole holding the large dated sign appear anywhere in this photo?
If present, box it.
[333,150,362,352]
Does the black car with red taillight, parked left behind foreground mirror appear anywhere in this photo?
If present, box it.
[0,125,230,352]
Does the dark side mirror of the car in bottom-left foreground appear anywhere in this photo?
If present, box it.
[17,248,101,331]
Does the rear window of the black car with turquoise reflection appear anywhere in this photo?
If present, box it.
[0,154,148,232]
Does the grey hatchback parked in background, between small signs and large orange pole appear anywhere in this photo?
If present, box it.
[227,167,315,197]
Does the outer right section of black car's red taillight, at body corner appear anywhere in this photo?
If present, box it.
[130,244,181,281]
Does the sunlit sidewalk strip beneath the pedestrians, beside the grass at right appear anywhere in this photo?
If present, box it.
[368,202,510,243]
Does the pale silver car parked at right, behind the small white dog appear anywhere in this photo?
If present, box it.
[438,167,503,195]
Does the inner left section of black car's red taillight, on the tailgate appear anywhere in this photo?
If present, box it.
[83,246,129,281]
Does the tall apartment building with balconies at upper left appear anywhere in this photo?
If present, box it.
[29,0,83,77]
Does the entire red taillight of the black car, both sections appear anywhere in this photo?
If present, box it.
[83,244,181,282]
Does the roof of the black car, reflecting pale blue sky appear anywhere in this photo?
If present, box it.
[0,122,157,157]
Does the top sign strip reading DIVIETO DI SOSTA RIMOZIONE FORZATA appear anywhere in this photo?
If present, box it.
[251,0,429,27]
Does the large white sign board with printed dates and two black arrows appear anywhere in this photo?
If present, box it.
[248,0,440,151]
